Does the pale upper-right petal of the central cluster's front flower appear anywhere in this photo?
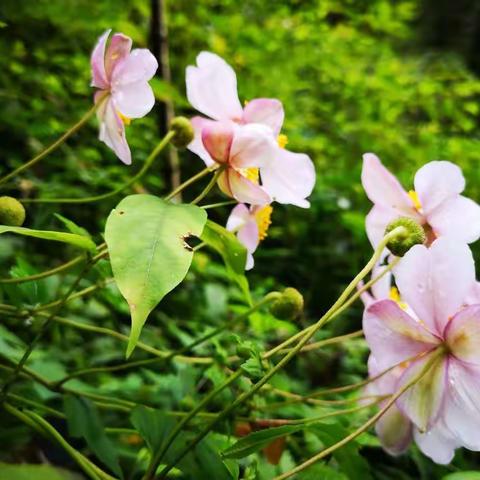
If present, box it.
[230,124,278,168]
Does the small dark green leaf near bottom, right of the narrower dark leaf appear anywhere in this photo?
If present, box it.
[130,405,175,452]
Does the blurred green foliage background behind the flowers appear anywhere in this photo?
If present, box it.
[0,0,480,479]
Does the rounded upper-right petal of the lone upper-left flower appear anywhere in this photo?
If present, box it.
[112,48,158,89]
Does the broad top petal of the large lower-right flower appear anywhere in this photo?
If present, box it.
[394,237,475,335]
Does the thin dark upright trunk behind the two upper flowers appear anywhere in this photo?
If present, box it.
[150,0,181,200]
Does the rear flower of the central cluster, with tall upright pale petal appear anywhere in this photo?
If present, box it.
[186,52,315,208]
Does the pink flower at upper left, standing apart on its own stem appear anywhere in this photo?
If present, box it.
[90,30,158,165]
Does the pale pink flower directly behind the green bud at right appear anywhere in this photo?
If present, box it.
[362,153,480,246]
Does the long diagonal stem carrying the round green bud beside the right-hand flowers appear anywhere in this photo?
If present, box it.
[154,227,405,480]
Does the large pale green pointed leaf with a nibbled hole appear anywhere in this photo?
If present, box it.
[105,195,207,357]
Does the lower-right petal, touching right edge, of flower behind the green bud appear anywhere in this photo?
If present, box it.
[427,195,480,243]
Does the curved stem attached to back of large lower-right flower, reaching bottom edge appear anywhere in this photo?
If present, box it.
[273,348,445,480]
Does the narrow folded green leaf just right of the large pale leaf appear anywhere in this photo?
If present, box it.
[201,220,252,304]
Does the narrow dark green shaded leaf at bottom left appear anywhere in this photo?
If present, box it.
[64,395,123,478]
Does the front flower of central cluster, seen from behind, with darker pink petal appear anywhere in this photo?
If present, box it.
[202,122,272,205]
